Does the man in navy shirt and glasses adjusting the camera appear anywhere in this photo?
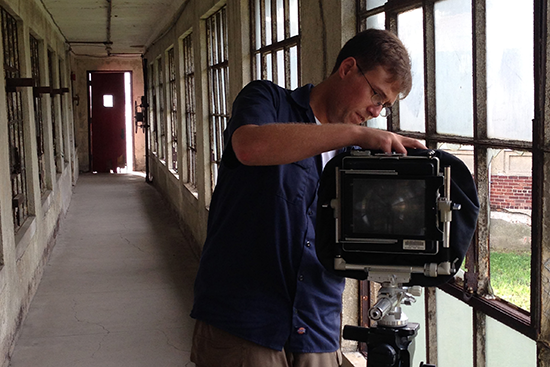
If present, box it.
[191,30,424,367]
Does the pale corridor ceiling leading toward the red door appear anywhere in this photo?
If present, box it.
[40,0,187,56]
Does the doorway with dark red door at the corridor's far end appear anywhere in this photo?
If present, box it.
[88,71,133,173]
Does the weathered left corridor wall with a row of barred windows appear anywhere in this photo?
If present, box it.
[0,0,79,361]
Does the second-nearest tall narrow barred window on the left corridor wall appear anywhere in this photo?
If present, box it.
[30,35,46,194]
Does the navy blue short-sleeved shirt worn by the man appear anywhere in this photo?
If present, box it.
[191,81,344,353]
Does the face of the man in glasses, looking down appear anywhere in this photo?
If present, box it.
[335,58,399,125]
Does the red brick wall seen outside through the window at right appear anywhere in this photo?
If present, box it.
[491,175,532,210]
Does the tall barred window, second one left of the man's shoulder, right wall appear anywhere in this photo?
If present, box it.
[182,35,197,188]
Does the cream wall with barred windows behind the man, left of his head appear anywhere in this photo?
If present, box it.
[145,0,358,360]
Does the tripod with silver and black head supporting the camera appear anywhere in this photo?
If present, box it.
[343,278,435,367]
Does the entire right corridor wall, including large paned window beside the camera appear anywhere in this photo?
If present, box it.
[146,0,550,367]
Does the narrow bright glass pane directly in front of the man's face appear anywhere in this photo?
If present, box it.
[397,8,426,132]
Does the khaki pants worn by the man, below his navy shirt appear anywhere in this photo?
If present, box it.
[191,321,342,367]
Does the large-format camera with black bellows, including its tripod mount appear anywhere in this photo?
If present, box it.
[316,150,479,367]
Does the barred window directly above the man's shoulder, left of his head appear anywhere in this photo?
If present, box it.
[250,0,300,89]
